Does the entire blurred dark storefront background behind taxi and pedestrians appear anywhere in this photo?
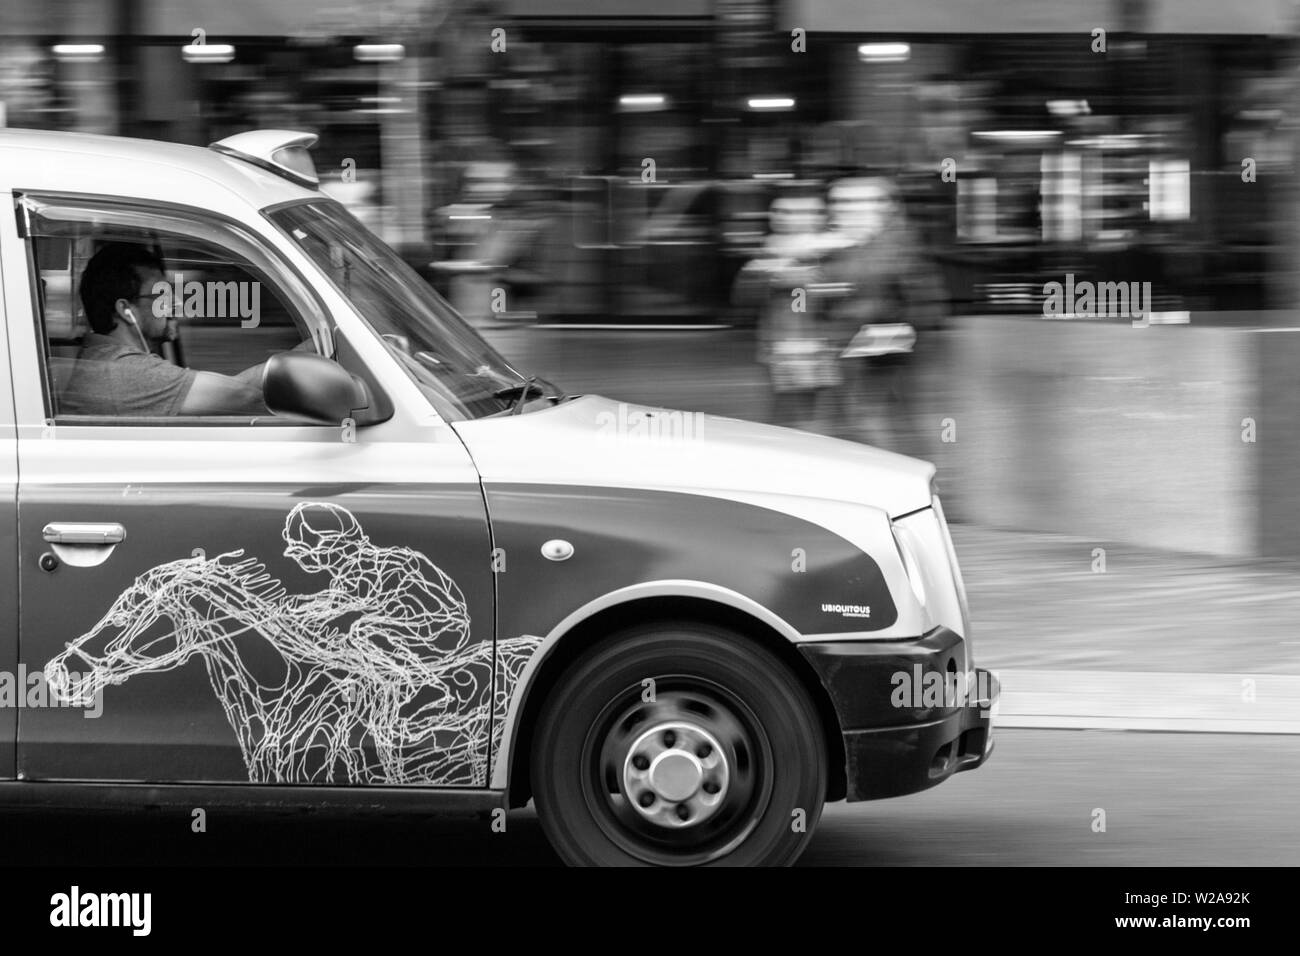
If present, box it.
[0,0,1297,323]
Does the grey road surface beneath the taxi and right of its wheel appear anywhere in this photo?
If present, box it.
[0,730,1300,866]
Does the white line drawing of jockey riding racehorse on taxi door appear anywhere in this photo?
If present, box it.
[46,502,541,786]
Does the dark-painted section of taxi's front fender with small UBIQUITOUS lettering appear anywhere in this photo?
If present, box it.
[486,484,898,647]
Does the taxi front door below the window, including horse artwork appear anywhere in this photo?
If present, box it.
[18,468,494,786]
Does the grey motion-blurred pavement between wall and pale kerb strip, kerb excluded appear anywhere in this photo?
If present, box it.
[953,524,1300,674]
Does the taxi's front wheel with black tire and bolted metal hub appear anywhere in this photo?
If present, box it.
[530,623,827,866]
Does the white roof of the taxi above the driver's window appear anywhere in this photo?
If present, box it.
[0,129,321,219]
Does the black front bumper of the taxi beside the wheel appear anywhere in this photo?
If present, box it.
[800,627,1001,801]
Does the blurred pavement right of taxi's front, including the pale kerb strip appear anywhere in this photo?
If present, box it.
[953,524,1300,734]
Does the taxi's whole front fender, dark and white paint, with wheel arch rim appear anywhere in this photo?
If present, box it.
[484,484,920,787]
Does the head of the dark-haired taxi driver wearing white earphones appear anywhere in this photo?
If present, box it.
[81,242,172,341]
